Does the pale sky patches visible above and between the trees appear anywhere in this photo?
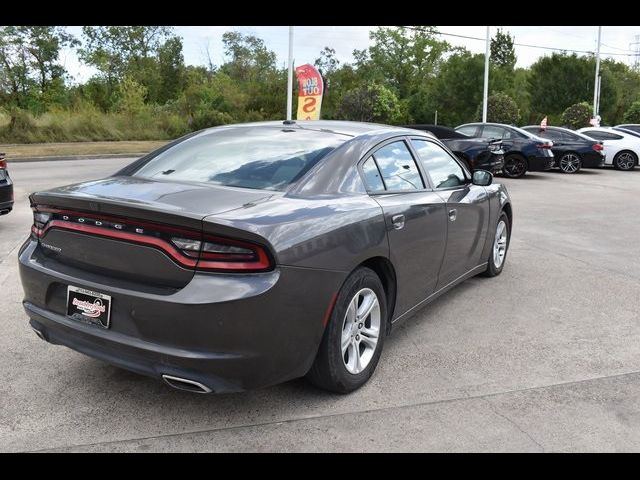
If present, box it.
[62,26,640,81]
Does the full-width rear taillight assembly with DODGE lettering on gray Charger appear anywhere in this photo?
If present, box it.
[31,207,273,272]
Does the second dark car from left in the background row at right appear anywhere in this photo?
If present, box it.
[456,123,555,178]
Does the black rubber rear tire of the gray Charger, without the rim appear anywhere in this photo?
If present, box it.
[307,267,388,393]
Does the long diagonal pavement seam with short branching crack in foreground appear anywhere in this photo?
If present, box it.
[23,371,640,453]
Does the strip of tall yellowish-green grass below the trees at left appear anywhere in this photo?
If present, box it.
[0,105,189,143]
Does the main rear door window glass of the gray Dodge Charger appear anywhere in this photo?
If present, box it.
[373,141,424,190]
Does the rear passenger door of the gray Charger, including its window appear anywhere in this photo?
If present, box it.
[360,138,447,317]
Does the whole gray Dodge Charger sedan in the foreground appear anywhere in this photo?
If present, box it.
[19,121,513,393]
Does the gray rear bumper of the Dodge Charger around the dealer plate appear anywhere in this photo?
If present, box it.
[19,240,345,393]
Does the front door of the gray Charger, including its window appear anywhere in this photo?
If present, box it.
[411,138,489,289]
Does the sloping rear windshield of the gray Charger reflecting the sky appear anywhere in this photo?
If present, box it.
[133,127,347,190]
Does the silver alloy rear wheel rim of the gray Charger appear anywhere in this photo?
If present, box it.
[341,288,380,375]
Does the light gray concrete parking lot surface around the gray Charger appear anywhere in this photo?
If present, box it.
[0,159,640,452]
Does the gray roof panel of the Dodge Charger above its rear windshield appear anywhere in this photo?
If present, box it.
[200,120,415,137]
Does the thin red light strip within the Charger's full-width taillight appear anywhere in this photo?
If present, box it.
[31,220,271,271]
